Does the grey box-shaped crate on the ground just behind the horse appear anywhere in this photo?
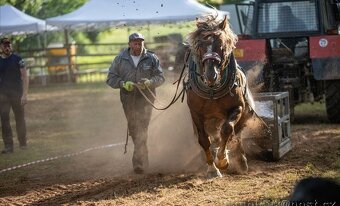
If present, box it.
[254,92,292,160]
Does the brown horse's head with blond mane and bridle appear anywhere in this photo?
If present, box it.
[189,15,237,87]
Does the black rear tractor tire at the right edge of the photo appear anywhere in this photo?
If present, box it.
[325,80,340,123]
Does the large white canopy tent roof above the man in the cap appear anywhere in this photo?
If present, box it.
[47,0,228,29]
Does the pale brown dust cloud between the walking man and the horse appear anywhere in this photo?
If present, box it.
[148,79,204,172]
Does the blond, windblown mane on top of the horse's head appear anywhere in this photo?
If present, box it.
[187,14,238,64]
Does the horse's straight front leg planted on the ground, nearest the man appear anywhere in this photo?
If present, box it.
[191,114,222,178]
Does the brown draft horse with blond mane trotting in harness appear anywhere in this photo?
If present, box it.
[187,15,254,177]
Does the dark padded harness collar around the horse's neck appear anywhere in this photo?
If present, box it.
[188,53,237,99]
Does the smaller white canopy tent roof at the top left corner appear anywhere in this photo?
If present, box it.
[0,4,53,35]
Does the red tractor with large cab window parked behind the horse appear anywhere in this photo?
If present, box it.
[231,0,340,123]
